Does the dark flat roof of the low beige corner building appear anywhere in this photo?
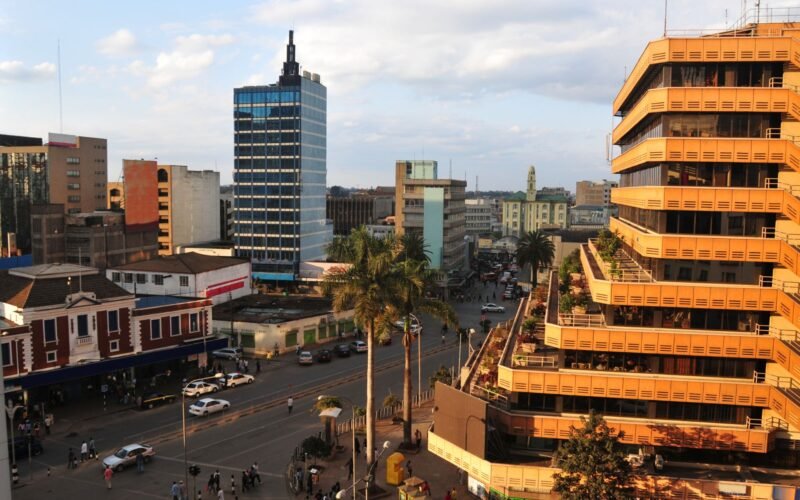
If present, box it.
[213,294,332,324]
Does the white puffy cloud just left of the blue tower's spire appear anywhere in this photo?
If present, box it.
[127,34,235,89]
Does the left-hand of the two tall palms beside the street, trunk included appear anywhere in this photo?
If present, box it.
[322,227,397,465]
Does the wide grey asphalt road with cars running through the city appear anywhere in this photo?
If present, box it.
[12,285,516,500]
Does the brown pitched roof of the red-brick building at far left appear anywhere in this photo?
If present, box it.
[0,264,130,309]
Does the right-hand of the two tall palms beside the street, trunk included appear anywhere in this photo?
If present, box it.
[392,258,458,448]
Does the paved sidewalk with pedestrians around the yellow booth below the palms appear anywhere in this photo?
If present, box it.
[297,401,475,499]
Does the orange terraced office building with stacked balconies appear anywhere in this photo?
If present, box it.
[428,9,800,499]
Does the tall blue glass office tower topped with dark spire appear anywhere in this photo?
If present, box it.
[233,31,333,281]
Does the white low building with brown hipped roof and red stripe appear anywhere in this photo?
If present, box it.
[106,252,252,304]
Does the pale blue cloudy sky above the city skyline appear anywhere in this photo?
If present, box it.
[0,0,780,191]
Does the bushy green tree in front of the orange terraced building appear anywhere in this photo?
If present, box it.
[553,410,633,500]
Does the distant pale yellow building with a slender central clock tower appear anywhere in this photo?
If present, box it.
[502,166,569,237]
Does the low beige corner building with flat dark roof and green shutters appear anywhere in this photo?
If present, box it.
[214,294,356,355]
